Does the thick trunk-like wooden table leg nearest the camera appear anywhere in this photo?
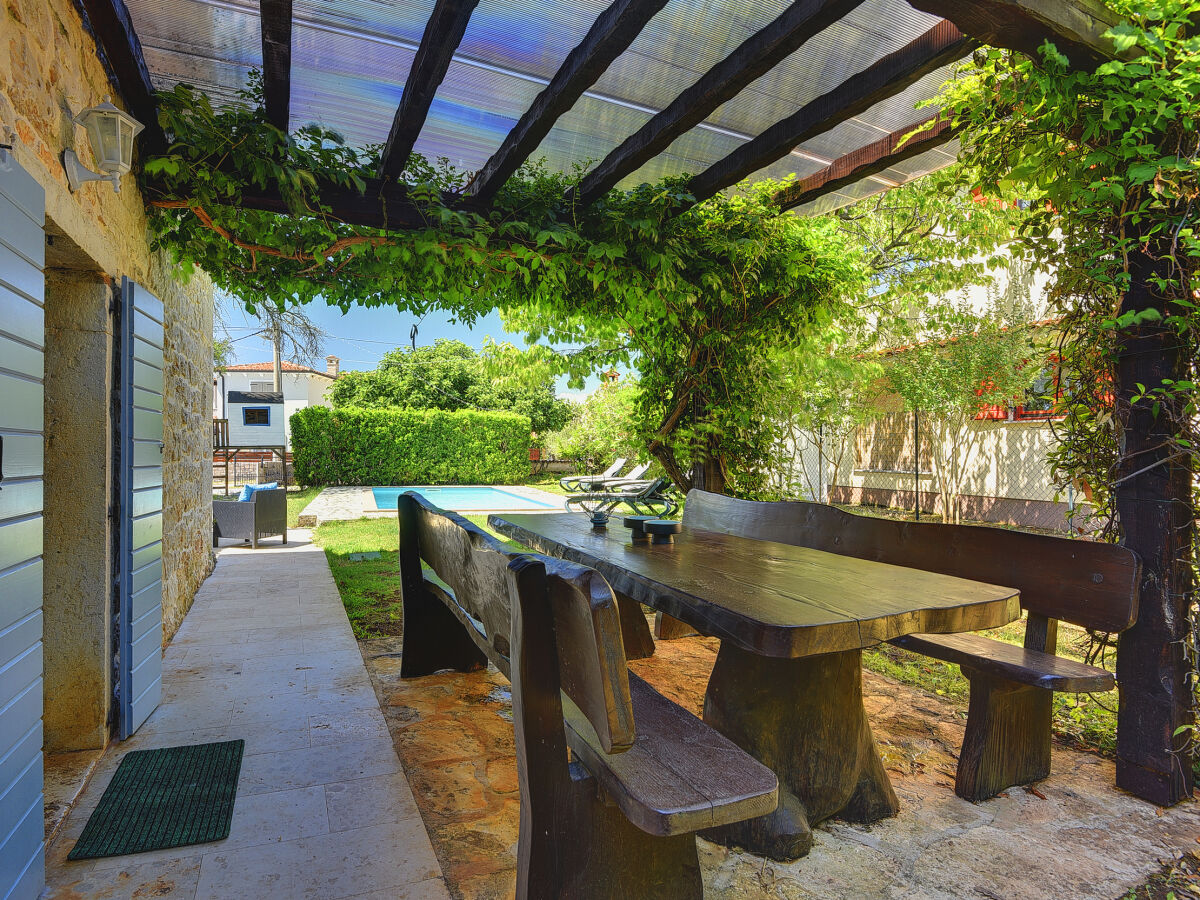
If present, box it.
[704,641,900,860]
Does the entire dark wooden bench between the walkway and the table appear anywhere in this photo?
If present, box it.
[396,493,778,900]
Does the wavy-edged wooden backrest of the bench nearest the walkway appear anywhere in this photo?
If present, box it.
[397,492,634,752]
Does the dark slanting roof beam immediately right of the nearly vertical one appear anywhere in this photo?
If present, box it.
[379,0,479,180]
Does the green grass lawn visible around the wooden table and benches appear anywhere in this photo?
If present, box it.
[312,508,1116,754]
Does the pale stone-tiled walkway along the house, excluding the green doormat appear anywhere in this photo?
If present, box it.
[44,530,450,900]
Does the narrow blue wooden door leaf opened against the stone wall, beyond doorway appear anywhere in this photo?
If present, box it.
[116,278,163,740]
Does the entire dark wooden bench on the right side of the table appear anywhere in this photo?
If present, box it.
[683,491,1141,800]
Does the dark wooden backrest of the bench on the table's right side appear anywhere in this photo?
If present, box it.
[683,490,1141,631]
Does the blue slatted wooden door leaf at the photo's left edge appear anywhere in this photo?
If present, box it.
[0,150,46,900]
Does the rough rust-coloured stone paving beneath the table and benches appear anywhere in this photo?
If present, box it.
[362,637,1200,900]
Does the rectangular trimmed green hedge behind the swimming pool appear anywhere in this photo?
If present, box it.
[292,407,529,485]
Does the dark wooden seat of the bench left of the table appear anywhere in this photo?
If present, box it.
[563,672,778,835]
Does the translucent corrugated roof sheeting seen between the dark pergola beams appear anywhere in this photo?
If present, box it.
[126,0,953,211]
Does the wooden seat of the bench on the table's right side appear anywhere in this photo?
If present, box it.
[890,634,1116,694]
